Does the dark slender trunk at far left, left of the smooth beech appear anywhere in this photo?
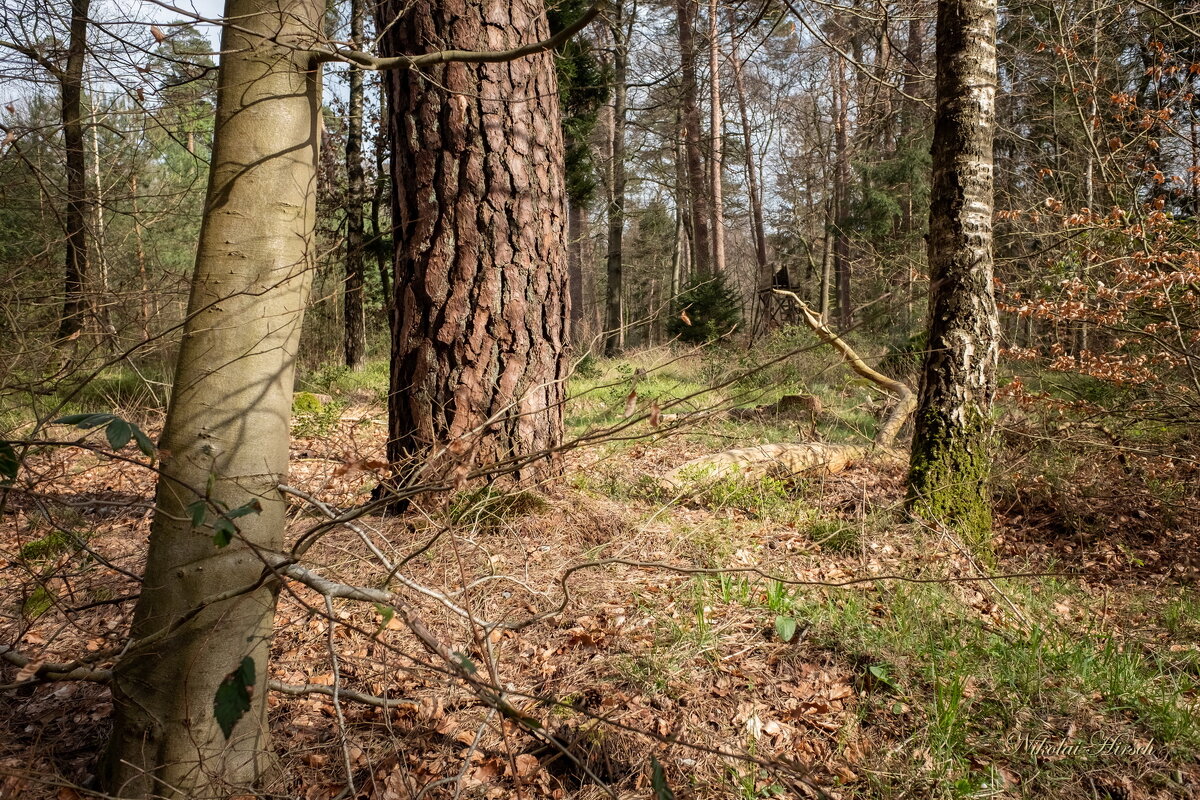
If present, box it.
[59,0,90,339]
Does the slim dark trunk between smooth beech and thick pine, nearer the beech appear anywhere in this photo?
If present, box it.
[342,0,367,369]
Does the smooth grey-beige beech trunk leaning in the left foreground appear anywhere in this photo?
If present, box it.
[102,0,324,799]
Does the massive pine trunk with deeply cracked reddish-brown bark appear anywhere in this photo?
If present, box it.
[379,0,568,489]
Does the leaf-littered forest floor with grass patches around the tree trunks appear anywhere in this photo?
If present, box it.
[0,345,1200,800]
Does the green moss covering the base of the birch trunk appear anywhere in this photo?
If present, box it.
[907,414,991,551]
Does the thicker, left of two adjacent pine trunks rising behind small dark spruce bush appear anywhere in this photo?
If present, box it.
[676,0,713,277]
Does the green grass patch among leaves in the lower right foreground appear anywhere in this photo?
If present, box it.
[704,554,1200,798]
